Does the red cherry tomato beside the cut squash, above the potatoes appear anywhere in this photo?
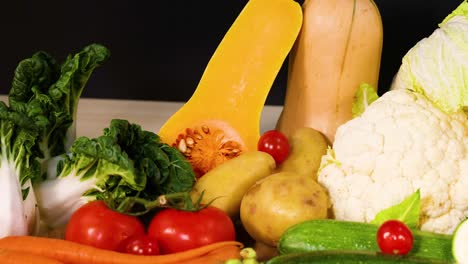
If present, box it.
[257,130,290,163]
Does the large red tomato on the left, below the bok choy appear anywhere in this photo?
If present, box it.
[65,201,145,251]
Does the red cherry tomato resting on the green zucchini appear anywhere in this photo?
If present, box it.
[377,220,414,255]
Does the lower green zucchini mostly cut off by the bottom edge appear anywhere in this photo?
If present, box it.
[266,251,446,264]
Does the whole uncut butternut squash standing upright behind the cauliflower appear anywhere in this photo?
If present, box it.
[277,0,383,143]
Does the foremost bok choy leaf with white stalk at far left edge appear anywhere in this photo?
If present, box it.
[0,102,40,237]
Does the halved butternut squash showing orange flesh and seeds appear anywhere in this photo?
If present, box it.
[158,0,302,177]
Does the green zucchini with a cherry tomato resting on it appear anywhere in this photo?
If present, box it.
[278,219,454,263]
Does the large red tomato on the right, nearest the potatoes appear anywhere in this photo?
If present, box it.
[148,206,236,254]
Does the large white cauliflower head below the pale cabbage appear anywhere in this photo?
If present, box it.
[318,89,468,233]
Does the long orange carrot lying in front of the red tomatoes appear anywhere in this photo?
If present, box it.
[0,236,242,264]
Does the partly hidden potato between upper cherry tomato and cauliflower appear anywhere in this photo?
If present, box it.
[277,127,328,180]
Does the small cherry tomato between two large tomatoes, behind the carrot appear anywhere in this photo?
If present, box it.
[121,234,159,255]
